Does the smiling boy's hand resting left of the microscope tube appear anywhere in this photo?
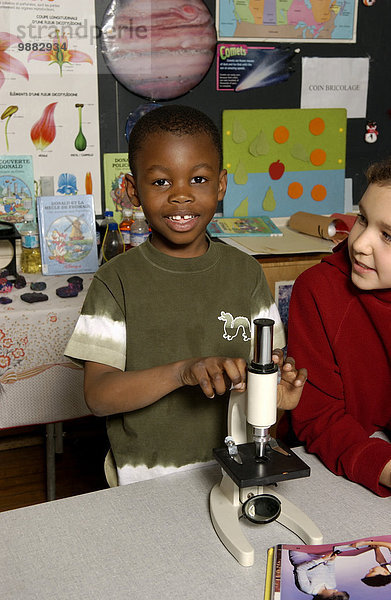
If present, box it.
[179,356,247,398]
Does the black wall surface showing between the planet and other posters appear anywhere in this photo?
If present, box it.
[95,0,391,213]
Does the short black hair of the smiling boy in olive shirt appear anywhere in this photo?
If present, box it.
[129,104,223,175]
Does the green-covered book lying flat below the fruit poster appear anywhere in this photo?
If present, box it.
[207,217,282,237]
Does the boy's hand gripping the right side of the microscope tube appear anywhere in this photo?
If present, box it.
[273,348,307,410]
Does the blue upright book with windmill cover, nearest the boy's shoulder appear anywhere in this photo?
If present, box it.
[37,194,98,275]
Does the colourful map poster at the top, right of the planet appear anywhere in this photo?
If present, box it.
[216,0,358,43]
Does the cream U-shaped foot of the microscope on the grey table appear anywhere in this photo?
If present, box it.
[209,472,323,567]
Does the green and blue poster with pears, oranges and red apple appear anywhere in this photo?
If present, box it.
[222,108,346,217]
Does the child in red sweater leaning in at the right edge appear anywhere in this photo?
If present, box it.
[280,159,391,496]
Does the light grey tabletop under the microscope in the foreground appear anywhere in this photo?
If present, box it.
[0,449,391,600]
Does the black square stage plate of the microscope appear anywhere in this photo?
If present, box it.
[213,441,310,488]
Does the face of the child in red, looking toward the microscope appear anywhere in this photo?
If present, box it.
[348,184,391,290]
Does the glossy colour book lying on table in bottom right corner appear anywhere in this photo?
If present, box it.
[264,535,391,600]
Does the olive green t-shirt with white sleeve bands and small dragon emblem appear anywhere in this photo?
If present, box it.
[65,240,285,482]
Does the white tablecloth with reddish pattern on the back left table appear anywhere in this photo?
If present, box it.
[0,274,93,429]
